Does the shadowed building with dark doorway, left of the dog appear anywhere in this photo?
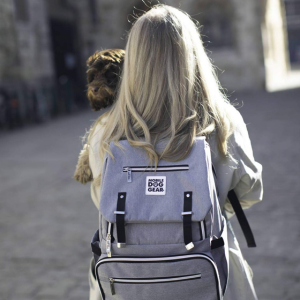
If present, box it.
[0,0,94,127]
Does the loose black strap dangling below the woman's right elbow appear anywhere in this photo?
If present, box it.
[212,165,256,248]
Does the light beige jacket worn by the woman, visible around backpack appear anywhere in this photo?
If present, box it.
[89,110,263,300]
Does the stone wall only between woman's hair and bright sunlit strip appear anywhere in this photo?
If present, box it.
[178,0,264,91]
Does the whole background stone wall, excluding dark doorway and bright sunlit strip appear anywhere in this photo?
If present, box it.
[0,0,294,91]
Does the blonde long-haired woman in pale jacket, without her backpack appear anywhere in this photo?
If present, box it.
[88,5,262,300]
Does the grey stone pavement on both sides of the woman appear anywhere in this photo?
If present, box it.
[0,90,300,300]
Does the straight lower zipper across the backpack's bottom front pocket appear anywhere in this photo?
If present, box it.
[109,273,201,295]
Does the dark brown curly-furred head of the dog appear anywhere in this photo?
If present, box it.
[87,49,125,110]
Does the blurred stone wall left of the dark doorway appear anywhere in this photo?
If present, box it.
[0,0,53,84]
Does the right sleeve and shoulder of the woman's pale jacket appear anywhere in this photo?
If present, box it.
[209,107,263,213]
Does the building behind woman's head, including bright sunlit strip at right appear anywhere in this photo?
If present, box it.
[95,0,300,91]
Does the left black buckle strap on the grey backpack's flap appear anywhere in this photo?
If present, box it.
[115,192,126,248]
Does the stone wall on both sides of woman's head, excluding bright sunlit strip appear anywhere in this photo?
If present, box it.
[95,0,265,91]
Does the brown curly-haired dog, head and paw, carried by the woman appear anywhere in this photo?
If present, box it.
[74,49,125,184]
